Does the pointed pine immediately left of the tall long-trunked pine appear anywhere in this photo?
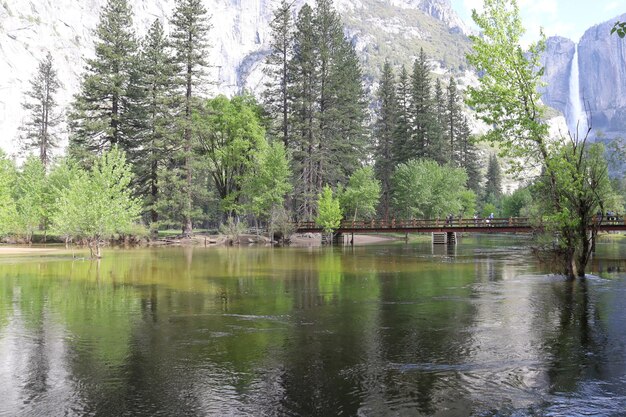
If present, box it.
[132,19,175,230]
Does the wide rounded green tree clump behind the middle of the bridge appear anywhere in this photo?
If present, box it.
[393,160,471,219]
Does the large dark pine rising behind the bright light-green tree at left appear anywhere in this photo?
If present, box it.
[70,0,137,161]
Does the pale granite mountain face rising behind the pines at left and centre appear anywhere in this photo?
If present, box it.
[0,0,469,151]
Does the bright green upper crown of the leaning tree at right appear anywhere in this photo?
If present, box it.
[467,0,548,166]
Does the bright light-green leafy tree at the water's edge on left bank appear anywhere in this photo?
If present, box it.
[52,147,141,257]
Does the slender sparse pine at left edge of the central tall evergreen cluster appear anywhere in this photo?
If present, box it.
[263,0,293,149]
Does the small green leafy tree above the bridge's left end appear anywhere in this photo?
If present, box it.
[338,166,381,220]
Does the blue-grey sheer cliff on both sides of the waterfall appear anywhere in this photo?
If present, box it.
[543,14,626,139]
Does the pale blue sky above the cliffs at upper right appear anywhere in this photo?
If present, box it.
[451,0,626,43]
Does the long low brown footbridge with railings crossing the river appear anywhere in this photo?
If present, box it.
[296,217,626,242]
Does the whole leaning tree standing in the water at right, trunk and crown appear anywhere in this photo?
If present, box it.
[468,0,610,279]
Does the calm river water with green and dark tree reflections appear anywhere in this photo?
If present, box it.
[0,237,626,416]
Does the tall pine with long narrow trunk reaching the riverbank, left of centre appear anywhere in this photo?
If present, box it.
[170,0,210,236]
